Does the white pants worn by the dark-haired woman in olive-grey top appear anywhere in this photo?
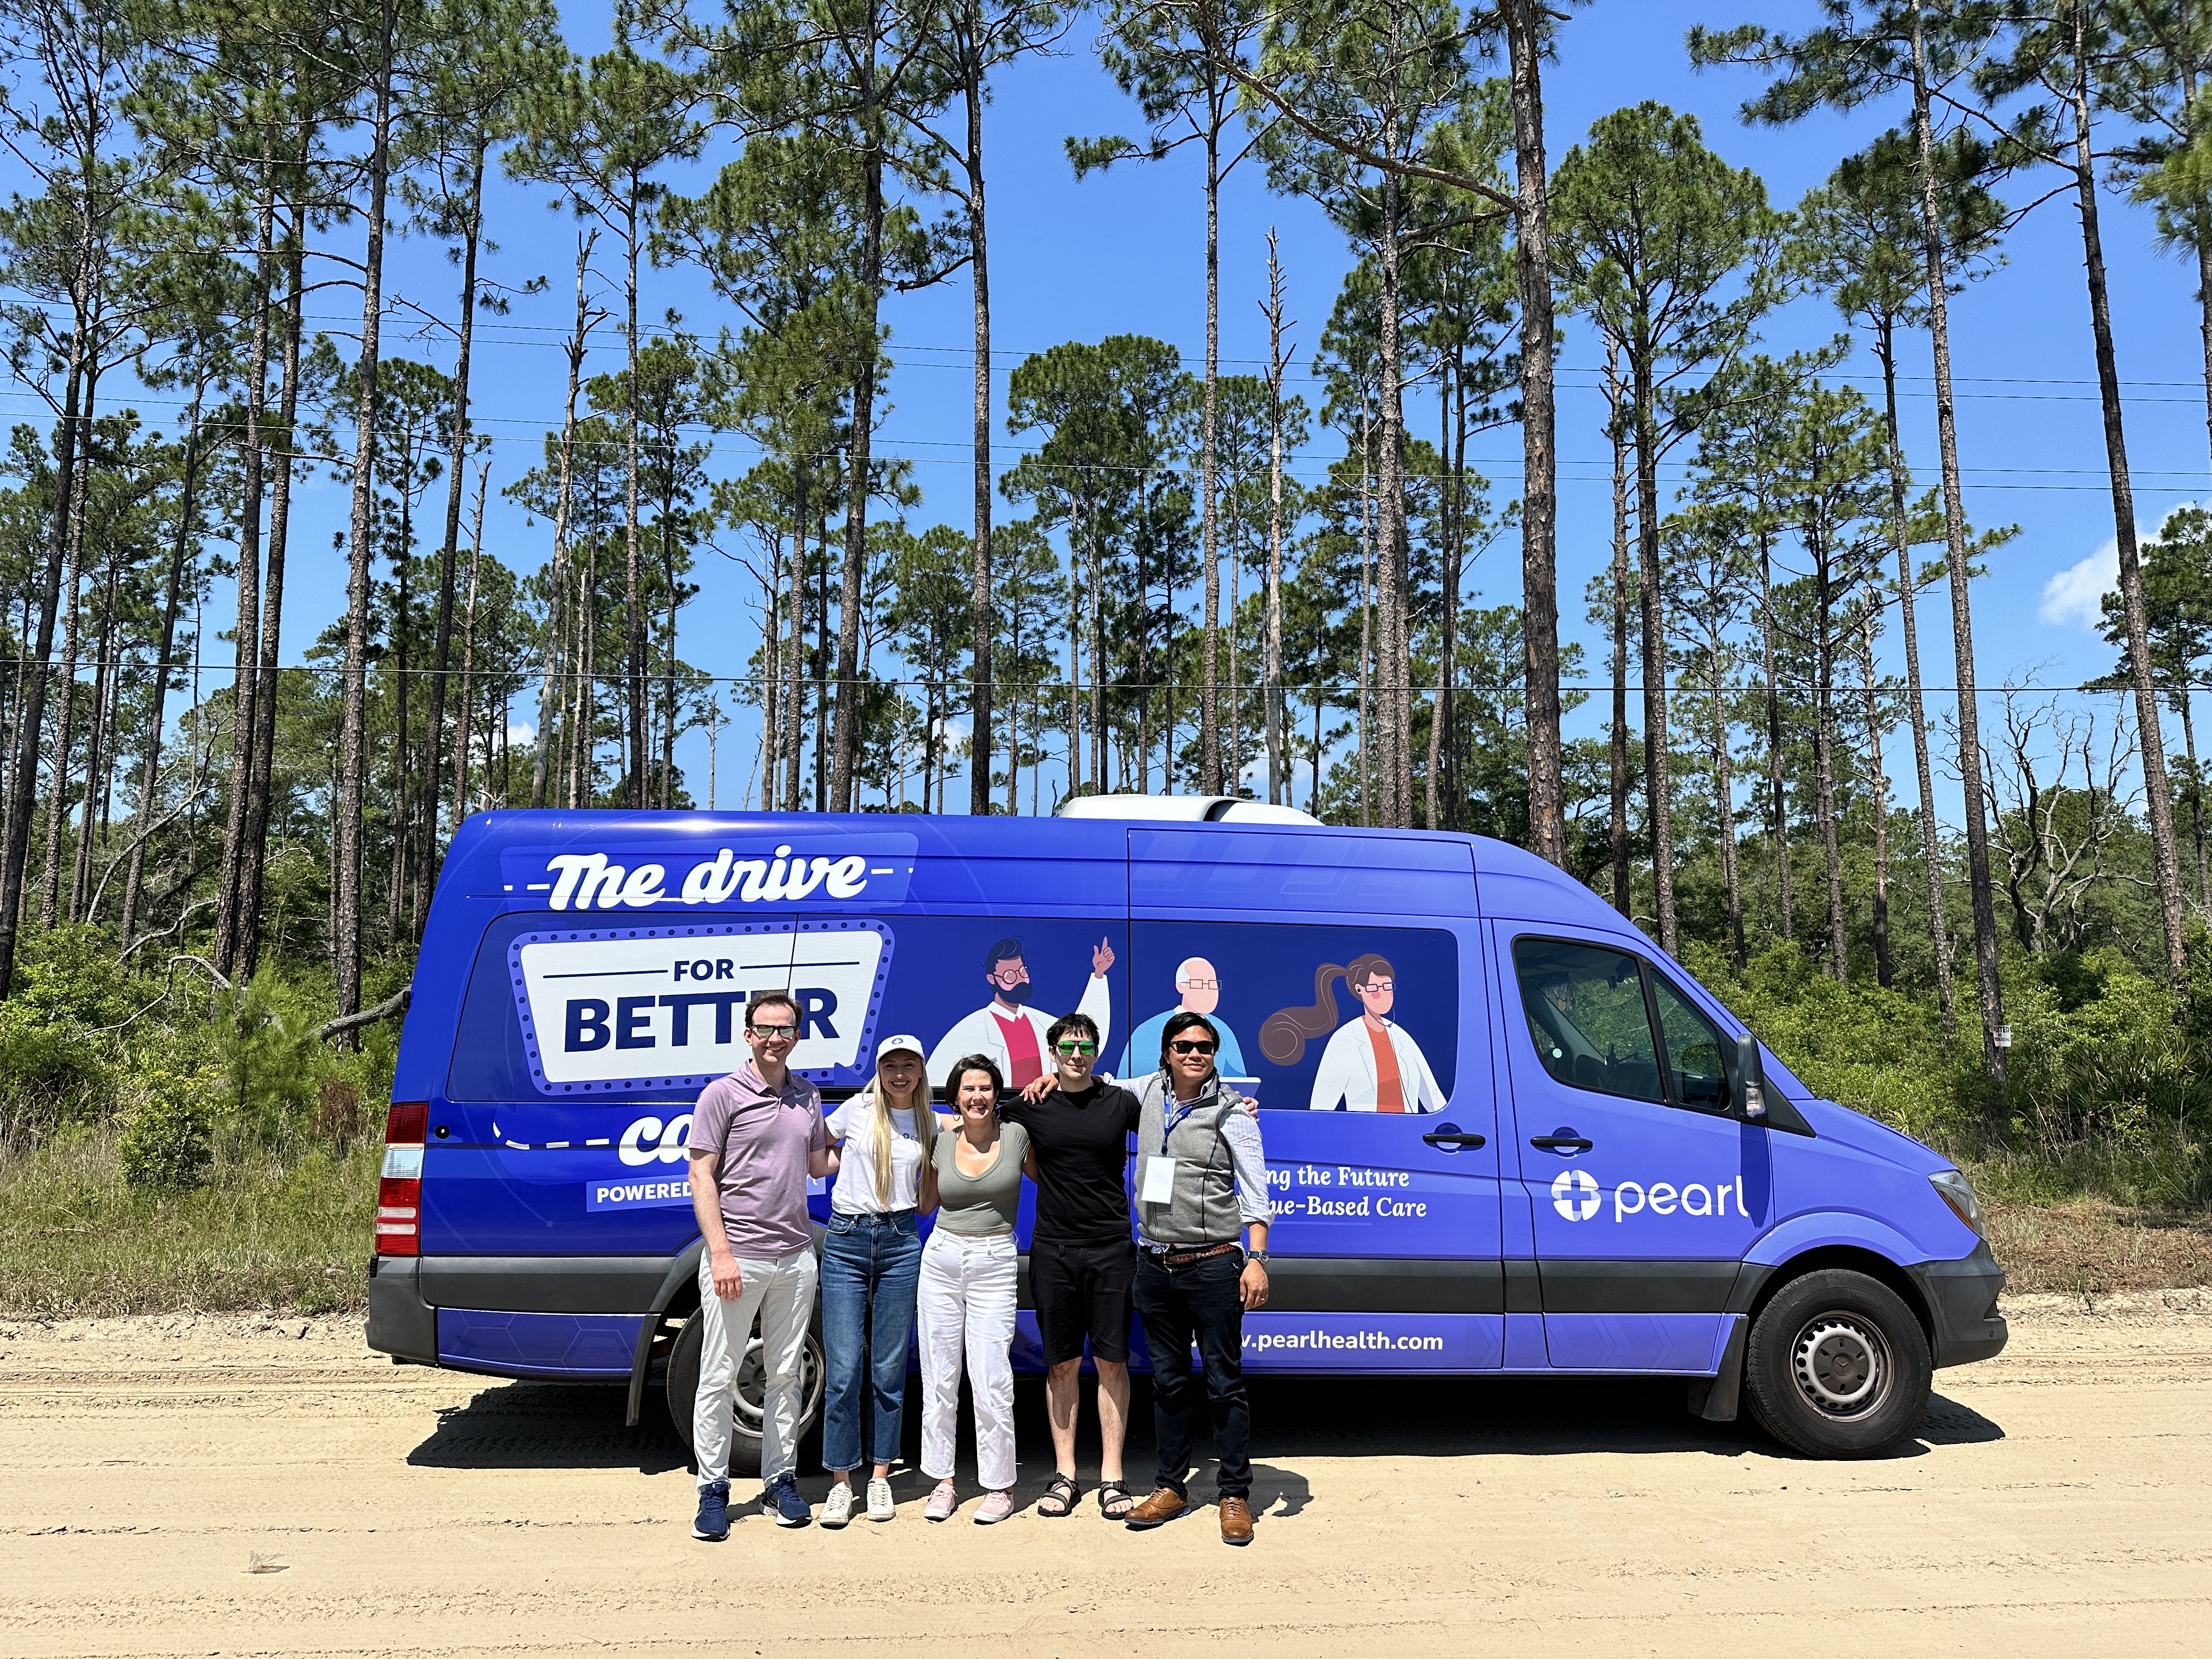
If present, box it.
[916,1226,1015,1491]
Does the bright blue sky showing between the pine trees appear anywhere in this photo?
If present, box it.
[0,0,2208,805]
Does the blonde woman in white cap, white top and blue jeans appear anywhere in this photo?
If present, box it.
[821,1035,940,1526]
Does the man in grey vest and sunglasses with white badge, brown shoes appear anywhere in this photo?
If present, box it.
[1128,1011,1274,1544]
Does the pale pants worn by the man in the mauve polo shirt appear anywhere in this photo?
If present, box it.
[692,1250,822,1487]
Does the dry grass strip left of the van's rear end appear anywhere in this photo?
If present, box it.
[0,1121,383,1318]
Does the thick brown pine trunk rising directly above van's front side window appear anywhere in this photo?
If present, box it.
[1504,0,1566,867]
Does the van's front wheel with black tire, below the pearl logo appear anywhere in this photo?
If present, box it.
[1743,1267,1936,1458]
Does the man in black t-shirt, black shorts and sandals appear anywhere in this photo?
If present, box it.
[1000,1013,1137,1520]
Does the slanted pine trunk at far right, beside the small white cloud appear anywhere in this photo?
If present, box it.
[2073,32,2188,980]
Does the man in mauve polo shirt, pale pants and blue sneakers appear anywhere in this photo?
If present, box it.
[690,991,836,1542]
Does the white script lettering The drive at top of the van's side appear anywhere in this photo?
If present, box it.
[500,832,916,911]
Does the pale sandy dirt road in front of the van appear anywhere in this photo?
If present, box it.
[0,1292,2212,1659]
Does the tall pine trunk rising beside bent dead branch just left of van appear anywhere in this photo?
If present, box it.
[336,0,394,1048]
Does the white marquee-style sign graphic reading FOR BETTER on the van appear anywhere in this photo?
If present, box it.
[509,920,891,1097]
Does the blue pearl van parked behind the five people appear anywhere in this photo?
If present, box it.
[369,797,2006,1458]
